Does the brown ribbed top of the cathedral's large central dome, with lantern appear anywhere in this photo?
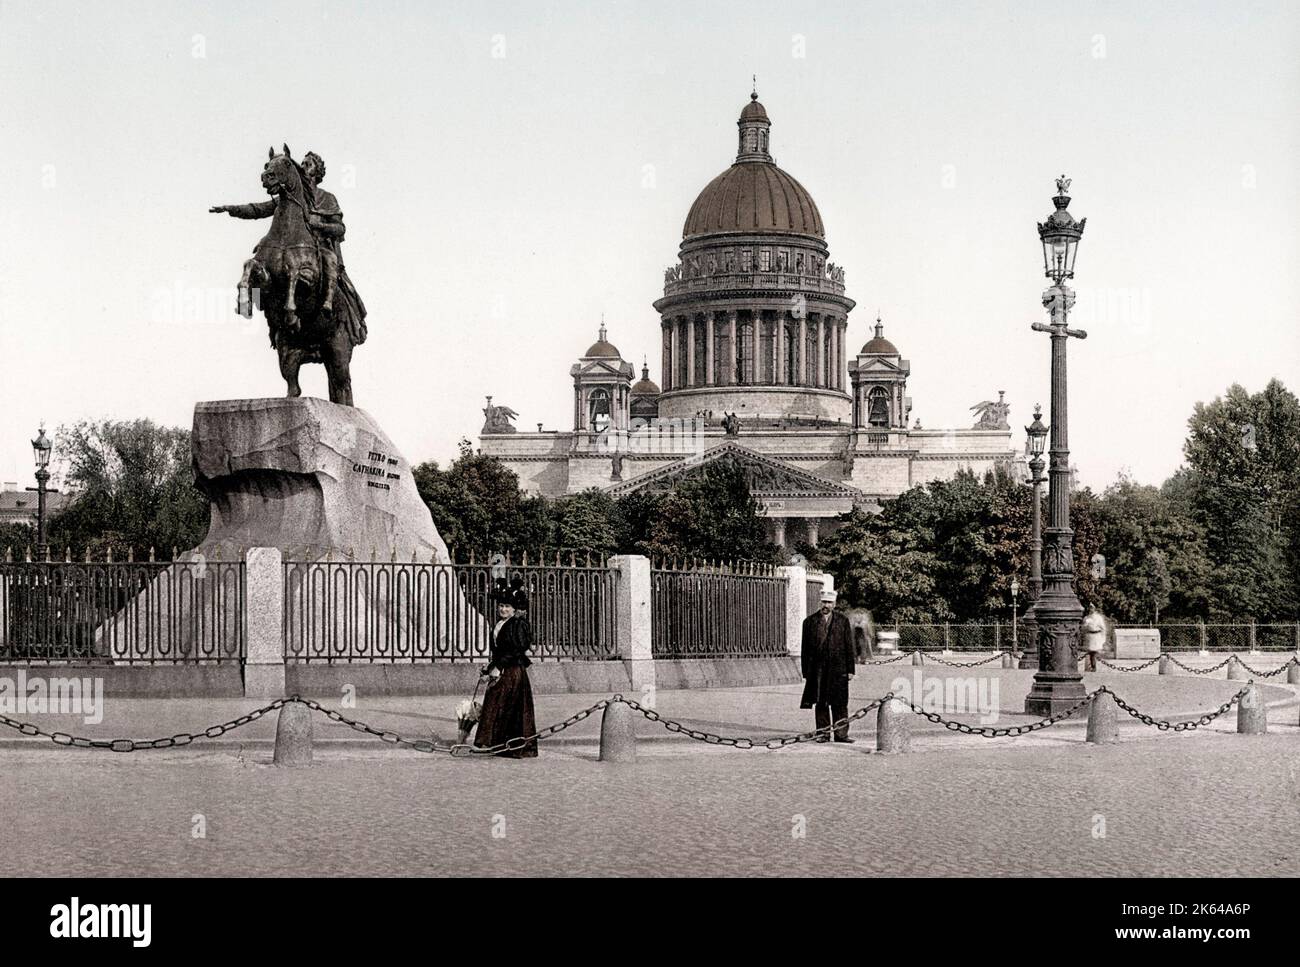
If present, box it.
[681,94,826,238]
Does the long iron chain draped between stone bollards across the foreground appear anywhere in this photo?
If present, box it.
[0,662,1268,758]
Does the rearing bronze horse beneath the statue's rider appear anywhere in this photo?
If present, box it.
[237,144,356,407]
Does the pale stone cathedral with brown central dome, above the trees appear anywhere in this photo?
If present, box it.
[480,94,1023,548]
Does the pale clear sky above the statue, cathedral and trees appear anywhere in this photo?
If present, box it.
[0,0,1300,487]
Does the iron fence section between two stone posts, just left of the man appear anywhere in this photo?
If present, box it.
[650,564,788,658]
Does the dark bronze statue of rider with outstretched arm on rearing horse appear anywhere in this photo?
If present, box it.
[208,144,365,407]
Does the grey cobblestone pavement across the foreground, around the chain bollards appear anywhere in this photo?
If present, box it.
[0,667,1300,876]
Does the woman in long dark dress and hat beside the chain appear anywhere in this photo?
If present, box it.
[475,593,537,759]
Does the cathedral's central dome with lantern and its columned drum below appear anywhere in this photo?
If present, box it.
[655,94,854,422]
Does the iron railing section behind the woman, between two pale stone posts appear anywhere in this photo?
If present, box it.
[283,561,618,662]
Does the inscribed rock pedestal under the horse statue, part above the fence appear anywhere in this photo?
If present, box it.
[192,396,450,564]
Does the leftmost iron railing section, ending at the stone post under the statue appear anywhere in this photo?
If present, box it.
[0,560,246,664]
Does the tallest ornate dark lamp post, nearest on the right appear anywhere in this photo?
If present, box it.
[1024,174,1088,715]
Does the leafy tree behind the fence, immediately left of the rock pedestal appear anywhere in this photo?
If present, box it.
[49,420,208,559]
